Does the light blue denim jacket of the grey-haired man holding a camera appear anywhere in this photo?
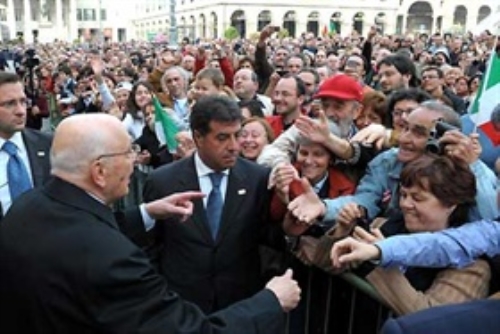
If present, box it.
[323,148,498,227]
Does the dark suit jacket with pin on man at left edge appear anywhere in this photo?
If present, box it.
[0,129,52,220]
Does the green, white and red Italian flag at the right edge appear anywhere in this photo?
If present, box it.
[469,49,500,146]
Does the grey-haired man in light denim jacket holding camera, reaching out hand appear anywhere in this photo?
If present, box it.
[289,101,498,228]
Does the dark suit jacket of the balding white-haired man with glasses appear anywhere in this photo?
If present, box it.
[0,178,284,334]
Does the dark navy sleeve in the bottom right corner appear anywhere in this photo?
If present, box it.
[382,300,500,334]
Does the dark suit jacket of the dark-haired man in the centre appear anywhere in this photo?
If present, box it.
[144,157,276,312]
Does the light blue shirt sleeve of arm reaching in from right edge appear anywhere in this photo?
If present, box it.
[376,220,500,268]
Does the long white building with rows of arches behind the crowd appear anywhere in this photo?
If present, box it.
[133,0,500,39]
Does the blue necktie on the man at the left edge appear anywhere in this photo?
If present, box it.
[2,141,31,202]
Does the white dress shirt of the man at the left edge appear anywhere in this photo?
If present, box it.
[0,131,33,215]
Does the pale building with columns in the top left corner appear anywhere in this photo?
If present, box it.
[0,0,135,42]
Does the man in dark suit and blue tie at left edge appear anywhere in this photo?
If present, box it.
[0,72,52,217]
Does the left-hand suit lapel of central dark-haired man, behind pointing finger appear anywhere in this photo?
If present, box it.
[179,156,213,243]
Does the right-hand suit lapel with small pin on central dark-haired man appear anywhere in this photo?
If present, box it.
[216,160,249,243]
